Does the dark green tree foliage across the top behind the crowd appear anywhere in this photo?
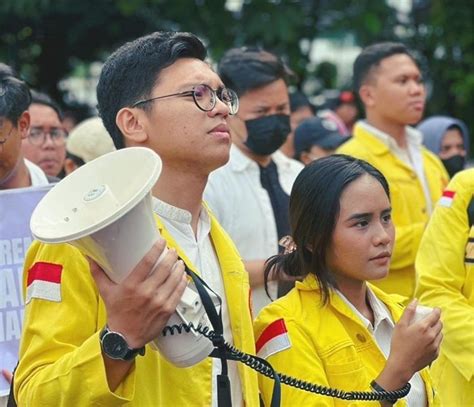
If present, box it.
[0,0,474,151]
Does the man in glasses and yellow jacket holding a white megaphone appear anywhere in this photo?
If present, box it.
[15,32,259,407]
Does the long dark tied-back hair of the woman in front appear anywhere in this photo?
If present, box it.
[265,154,390,303]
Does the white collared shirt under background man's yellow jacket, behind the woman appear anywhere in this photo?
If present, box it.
[358,120,433,214]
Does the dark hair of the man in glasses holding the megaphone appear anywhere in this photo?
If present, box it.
[97,32,206,149]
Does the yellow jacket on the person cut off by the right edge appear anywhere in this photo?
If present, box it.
[416,169,474,407]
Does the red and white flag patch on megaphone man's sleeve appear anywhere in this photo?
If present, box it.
[26,262,63,304]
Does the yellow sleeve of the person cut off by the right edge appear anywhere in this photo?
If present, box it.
[416,170,474,381]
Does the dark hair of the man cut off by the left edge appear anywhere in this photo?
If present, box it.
[0,63,31,126]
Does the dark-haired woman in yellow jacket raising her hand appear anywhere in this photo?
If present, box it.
[254,155,442,407]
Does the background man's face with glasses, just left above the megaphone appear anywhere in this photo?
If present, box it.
[22,91,67,177]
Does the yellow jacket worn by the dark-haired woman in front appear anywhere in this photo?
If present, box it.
[254,275,437,407]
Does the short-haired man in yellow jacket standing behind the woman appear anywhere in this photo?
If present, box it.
[337,43,448,297]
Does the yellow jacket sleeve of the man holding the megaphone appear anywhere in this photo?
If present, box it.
[15,242,135,407]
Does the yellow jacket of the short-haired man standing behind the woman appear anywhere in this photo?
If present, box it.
[337,124,448,298]
